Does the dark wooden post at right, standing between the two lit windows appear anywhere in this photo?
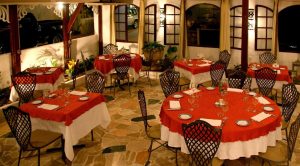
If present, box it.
[241,0,249,71]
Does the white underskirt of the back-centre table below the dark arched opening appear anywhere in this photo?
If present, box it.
[174,66,211,87]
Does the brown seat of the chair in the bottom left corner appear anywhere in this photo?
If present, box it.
[30,130,62,148]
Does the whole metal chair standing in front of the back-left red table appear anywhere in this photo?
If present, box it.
[111,54,131,95]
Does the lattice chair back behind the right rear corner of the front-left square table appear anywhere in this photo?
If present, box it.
[85,70,105,93]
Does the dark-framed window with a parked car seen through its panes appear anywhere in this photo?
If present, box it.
[115,5,139,42]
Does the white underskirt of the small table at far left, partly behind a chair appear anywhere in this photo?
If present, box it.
[9,74,65,101]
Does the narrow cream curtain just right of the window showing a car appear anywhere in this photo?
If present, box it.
[138,0,147,54]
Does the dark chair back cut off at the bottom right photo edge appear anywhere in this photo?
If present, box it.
[287,114,300,160]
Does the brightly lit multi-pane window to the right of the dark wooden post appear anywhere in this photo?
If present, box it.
[255,5,273,51]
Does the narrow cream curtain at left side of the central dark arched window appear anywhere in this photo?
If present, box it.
[178,0,189,59]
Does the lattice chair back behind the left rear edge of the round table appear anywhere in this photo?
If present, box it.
[159,69,180,97]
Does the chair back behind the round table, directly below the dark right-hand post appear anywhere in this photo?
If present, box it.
[228,70,247,89]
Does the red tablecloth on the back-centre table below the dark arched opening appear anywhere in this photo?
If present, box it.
[174,59,210,74]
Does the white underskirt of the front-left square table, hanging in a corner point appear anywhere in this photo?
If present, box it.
[31,102,111,161]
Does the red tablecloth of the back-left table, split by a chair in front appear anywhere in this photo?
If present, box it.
[94,54,142,74]
